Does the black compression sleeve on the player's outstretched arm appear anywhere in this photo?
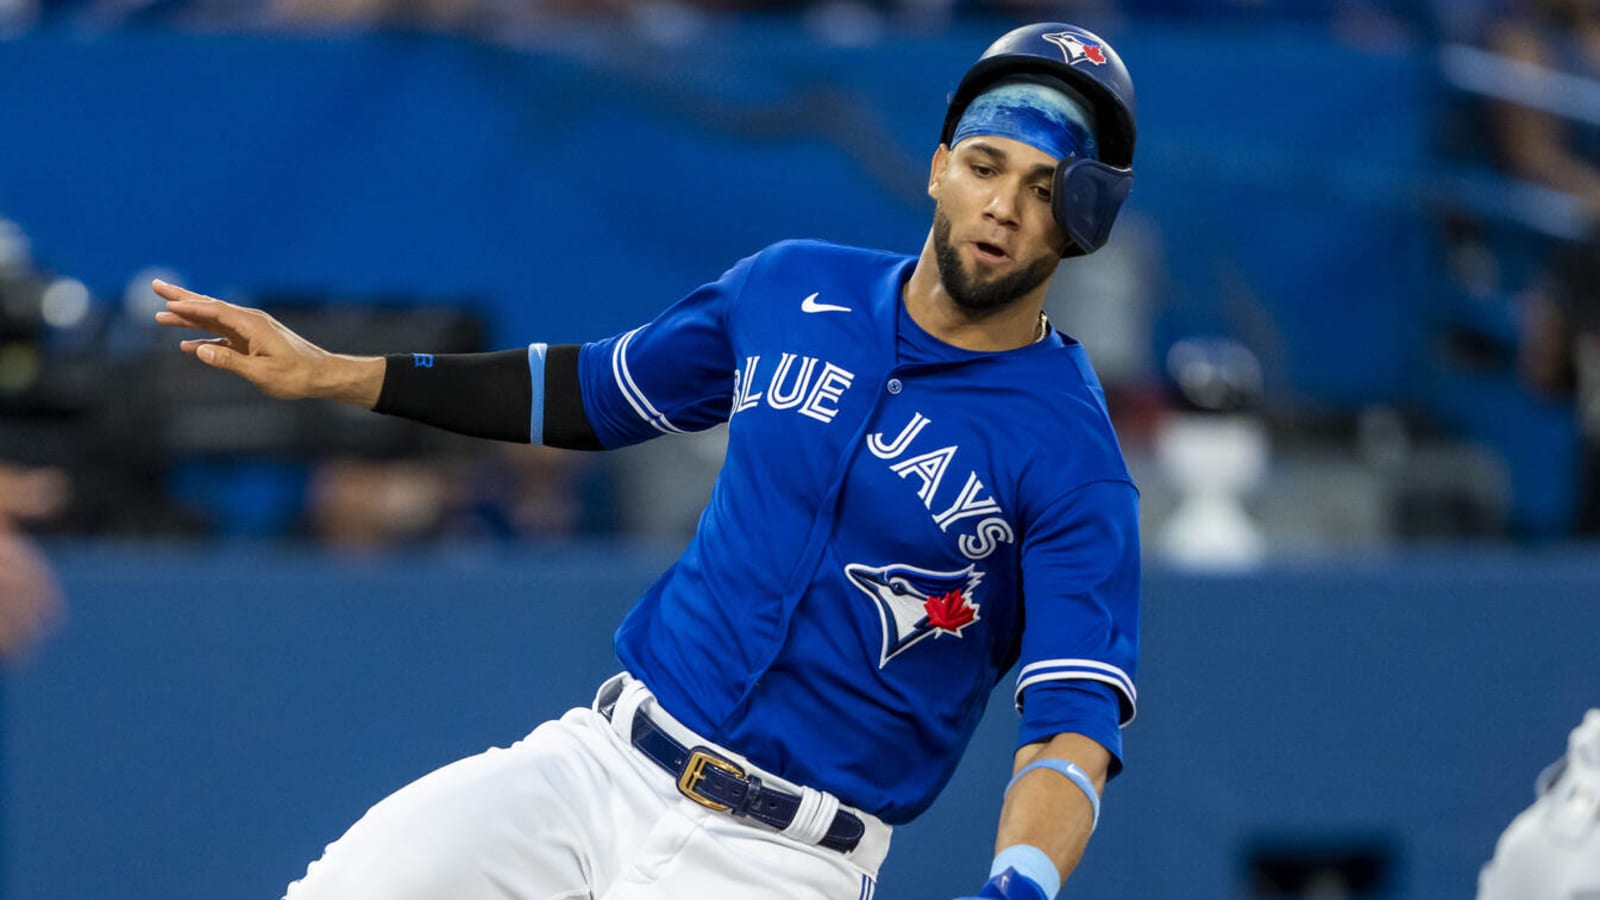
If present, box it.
[373,344,602,450]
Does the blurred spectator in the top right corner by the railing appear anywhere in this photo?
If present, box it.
[1490,0,1600,218]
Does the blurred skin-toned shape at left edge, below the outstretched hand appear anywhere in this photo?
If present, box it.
[0,463,67,661]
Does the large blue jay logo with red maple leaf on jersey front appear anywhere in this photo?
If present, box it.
[845,562,984,669]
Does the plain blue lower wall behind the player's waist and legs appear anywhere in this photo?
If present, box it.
[3,546,1600,900]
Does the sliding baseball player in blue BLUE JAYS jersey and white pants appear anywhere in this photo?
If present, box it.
[155,22,1139,900]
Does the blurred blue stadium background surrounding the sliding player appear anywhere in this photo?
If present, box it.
[0,0,1600,900]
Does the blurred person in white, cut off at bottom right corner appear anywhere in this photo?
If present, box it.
[1478,709,1600,900]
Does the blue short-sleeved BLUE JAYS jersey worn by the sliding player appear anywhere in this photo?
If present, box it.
[563,242,1139,823]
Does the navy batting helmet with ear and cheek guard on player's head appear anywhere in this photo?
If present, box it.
[939,22,1136,256]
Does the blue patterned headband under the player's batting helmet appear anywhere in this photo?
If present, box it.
[950,82,1099,160]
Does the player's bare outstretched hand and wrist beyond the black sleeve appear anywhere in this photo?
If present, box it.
[150,280,384,408]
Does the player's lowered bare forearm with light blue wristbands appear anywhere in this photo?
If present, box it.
[970,733,1110,900]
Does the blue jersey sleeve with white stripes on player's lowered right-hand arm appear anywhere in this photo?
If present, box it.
[1014,480,1139,733]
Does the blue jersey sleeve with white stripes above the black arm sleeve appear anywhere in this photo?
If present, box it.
[578,249,755,448]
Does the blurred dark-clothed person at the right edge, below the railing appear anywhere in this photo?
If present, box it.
[1518,229,1600,535]
